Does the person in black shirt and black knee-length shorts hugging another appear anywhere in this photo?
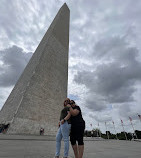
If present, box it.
[67,100,85,158]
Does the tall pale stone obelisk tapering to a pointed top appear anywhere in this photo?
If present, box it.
[0,4,70,135]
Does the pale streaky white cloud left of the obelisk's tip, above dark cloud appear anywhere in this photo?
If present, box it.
[0,0,61,51]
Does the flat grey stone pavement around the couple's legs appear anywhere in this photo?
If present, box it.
[0,135,141,158]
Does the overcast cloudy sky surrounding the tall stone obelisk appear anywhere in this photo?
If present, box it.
[0,0,141,133]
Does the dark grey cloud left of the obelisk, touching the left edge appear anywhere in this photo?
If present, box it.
[0,46,32,87]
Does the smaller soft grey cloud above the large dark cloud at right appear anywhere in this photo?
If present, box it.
[93,36,139,63]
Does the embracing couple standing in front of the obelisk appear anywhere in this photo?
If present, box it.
[55,98,85,158]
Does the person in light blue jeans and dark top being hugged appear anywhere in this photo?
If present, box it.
[55,98,71,158]
